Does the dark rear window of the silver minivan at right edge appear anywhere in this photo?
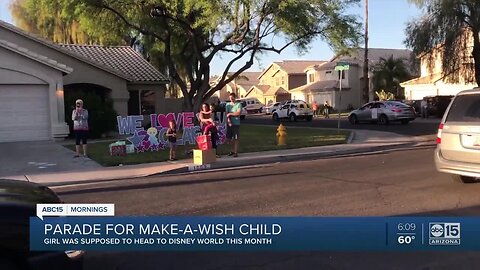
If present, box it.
[445,94,480,122]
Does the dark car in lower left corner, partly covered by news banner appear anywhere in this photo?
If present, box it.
[0,179,83,269]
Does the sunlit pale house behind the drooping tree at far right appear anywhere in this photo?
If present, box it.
[400,38,477,100]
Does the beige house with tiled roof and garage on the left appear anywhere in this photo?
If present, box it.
[0,21,168,142]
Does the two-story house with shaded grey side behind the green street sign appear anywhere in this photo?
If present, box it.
[290,48,411,110]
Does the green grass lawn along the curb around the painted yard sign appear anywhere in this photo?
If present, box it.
[66,125,350,166]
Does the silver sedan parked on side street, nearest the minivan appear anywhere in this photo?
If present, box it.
[348,101,415,125]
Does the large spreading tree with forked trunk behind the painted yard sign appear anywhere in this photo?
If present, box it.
[82,0,361,110]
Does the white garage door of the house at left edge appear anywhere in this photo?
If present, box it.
[0,85,51,142]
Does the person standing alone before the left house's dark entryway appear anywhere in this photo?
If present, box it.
[72,99,88,157]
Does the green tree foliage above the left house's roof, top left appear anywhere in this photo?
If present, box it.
[9,0,131,45]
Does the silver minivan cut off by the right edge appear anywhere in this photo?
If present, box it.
[434,88,480,183]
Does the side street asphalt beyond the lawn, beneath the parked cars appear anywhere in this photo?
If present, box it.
[242,115,441,136]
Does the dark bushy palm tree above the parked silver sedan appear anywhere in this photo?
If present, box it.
[373,55,411,98]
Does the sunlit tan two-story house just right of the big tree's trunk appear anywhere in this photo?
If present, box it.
[246,60,325,104]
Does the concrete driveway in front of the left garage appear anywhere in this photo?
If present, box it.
[0,141,101,180]
